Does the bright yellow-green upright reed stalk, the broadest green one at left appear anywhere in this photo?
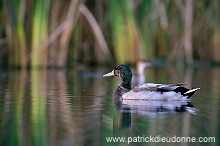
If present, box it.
[31,0,49,66]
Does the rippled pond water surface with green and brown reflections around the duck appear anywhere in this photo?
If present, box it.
[0,67,220,146]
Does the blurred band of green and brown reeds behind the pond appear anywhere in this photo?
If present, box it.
[0,0,220,68]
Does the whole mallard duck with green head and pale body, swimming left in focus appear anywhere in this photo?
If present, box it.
[103,64,200,100]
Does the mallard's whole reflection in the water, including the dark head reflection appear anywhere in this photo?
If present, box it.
[111,99,198,130]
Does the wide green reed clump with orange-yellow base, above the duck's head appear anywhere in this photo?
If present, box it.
[107,0,141,63]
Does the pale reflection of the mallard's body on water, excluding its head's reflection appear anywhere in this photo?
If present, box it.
[113,99,198,116]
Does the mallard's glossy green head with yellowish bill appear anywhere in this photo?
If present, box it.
[103,64,132,89]
